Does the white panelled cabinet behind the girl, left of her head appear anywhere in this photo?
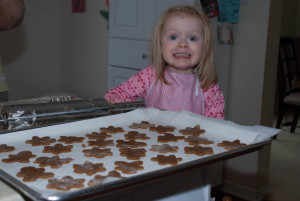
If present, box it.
[108,0,199,89]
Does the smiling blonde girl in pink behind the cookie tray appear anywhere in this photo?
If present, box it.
[104,6,225,119]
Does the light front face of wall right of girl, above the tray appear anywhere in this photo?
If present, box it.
[227,0,276,125]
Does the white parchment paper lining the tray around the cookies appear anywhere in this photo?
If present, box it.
[0,108,279,200]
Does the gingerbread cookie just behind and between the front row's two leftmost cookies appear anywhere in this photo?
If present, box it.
[34,156,74,168]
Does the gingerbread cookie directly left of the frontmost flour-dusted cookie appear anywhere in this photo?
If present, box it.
[17,166,54,182]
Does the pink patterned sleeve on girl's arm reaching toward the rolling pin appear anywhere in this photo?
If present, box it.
[104,66,155,103]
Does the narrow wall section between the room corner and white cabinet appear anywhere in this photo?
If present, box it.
[60,0,108,98]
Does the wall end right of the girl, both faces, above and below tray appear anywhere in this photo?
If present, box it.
[222,0,283,200]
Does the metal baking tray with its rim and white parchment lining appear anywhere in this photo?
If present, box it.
[0,108,277,200]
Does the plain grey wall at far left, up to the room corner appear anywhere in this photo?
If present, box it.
[0,0,60,100]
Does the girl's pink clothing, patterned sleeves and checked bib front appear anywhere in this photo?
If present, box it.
[104,66,225,119]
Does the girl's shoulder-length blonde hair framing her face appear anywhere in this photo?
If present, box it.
[152,6,218,90]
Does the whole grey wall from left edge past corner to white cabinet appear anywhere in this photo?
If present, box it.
[0,0,108,100]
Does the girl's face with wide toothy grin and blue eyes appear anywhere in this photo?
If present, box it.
[161,14,203,74]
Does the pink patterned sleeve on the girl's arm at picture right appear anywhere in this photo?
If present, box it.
[203,84,225,119]
